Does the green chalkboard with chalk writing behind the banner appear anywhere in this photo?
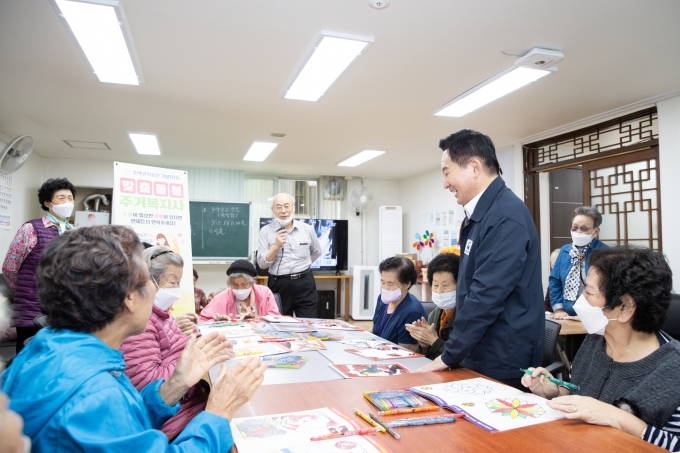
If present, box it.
[189,201,250,260]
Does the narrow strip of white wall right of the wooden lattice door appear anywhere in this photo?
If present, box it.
[657,96,680,293]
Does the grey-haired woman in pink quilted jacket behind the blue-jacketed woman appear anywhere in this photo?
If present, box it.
[120,246,233,440]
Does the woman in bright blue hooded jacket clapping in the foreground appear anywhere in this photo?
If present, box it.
[3,225,266,452]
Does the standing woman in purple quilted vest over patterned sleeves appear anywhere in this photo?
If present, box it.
[2,178,76,354]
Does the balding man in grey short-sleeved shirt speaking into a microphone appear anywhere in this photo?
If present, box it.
[257,193,321,318]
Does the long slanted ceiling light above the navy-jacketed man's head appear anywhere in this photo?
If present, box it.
[434,66,556,118]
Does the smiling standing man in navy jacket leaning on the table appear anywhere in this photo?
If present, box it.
[418,129,545,390]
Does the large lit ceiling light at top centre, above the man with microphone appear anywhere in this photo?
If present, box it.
[284,31,373,101]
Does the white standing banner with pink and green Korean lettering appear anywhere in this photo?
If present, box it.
[111,162,194,315]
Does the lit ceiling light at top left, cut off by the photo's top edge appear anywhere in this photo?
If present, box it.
[53,0,140,85]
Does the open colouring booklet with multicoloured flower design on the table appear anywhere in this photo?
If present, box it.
[410,378,564,431]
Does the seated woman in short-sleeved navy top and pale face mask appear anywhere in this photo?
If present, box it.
[373,256,427,351]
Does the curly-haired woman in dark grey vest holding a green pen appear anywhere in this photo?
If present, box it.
[522,247,680,451]
